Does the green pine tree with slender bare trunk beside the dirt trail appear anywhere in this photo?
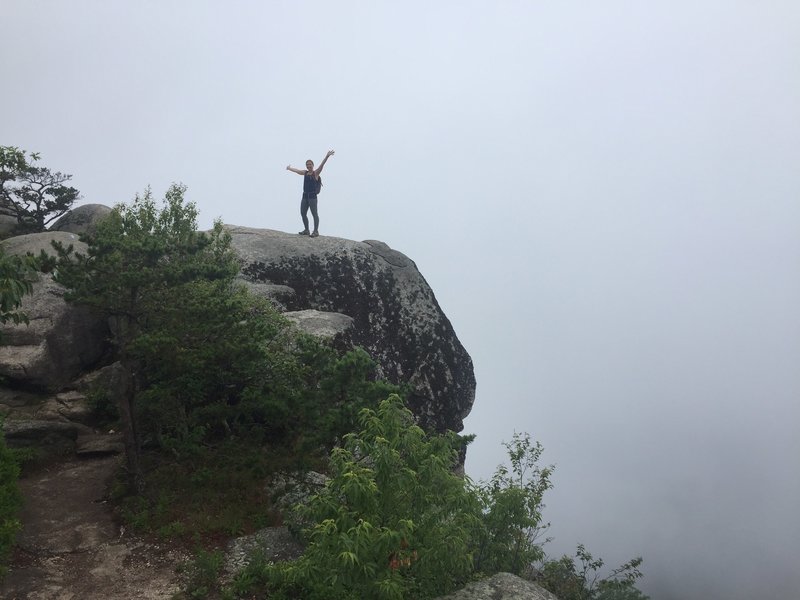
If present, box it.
[55,184,238,491]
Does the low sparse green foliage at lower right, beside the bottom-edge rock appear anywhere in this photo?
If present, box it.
[538,544,648,600]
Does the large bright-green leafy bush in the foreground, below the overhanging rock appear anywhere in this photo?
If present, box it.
[231,395,480,598]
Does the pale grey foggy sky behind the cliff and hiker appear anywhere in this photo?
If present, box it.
[0,0,800,600]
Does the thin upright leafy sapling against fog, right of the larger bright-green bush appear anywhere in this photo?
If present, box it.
[475,433,553,575]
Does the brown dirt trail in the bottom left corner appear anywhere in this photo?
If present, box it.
[0,456,189,600]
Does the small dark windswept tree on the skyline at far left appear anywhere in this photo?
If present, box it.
[0,146,80,233]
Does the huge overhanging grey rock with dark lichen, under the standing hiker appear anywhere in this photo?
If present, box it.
[228,226,475,431]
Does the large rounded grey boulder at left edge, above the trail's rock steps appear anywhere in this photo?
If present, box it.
[0,274,108,391]
